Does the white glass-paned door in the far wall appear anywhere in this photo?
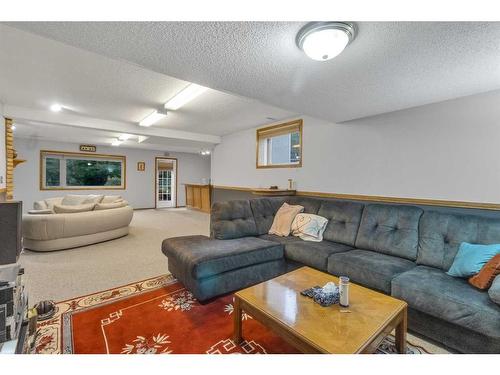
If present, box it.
[156,158,177,208]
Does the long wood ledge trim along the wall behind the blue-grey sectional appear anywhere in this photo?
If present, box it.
[212,185,500,211]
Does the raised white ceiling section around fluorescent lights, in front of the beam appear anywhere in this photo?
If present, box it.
[0,25,293,140]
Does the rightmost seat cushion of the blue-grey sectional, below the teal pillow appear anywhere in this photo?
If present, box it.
[392,266,500,339]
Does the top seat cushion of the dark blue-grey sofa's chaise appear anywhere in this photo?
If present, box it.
[162,236,283,279]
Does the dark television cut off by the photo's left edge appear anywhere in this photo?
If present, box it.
[0,201,23,265]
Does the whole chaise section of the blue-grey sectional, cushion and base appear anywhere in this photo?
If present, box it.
[162,236,287,301]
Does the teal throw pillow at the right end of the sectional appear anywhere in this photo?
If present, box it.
[446,242,500,277]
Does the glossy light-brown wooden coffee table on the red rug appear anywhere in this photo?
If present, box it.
[234,267,407,354]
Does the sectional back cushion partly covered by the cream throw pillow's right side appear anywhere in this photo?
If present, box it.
[318,201,363,246]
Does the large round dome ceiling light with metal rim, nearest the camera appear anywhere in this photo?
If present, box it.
[295,22,356,61]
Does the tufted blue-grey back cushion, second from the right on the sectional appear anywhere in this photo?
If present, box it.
[356,204,423,260]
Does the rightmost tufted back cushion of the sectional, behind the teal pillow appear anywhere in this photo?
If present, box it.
[417,211,500,271]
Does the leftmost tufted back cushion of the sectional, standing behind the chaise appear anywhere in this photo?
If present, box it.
[210,200,258,240]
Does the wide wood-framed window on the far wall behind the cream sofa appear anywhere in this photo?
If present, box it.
[40,151,126,190]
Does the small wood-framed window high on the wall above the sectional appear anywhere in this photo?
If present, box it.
[257,120,302,168]
